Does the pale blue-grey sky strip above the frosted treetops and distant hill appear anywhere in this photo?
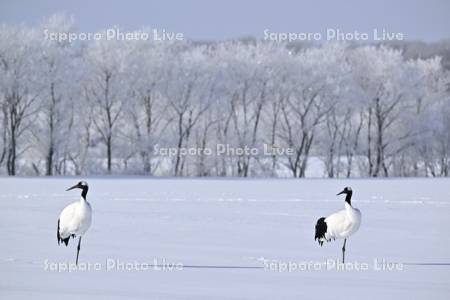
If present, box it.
[0,0,450,41]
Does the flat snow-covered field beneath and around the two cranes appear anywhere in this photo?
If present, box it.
[0,178,450,300]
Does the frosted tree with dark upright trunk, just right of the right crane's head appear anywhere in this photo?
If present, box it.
[351,46,417,177]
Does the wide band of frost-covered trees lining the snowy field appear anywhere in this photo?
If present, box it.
[0,15,450,178]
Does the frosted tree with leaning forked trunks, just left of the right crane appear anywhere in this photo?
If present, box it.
[280,45,348,177]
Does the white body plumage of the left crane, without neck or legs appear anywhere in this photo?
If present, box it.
[59,197,92,239]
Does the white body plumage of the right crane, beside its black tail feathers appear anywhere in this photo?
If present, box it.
[321,202,361,241]
